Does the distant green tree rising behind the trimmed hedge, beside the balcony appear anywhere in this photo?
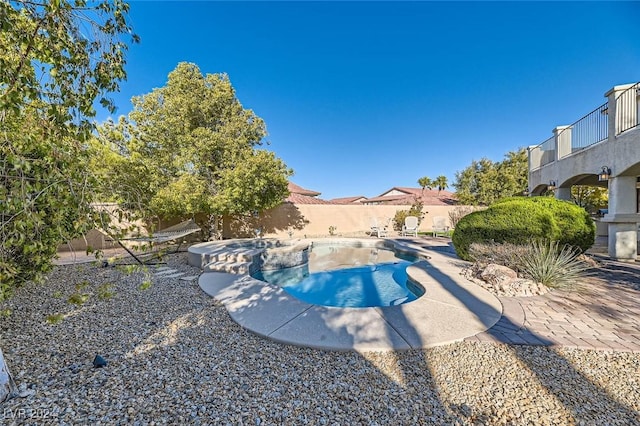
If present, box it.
[453,148,529,205]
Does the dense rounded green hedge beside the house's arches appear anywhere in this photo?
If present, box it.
[452,197,595,260]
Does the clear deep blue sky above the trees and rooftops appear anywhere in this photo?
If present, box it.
[104,1,640,199]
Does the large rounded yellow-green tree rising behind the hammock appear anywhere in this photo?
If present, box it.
[93,63,292,238]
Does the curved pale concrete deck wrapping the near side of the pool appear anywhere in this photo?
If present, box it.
[199,239,502,351]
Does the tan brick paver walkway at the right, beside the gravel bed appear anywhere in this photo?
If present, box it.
[467,259,640,352]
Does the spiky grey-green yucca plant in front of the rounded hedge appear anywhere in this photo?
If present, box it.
[520,241,589,288]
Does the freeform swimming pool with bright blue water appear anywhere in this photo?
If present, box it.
[252,245,424,308]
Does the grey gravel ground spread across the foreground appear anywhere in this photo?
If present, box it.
[0,254,640,425]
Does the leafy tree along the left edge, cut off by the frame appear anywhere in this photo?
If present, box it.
[0,0,138,402]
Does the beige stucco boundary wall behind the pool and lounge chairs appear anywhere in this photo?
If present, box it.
[224,204,468,238]
